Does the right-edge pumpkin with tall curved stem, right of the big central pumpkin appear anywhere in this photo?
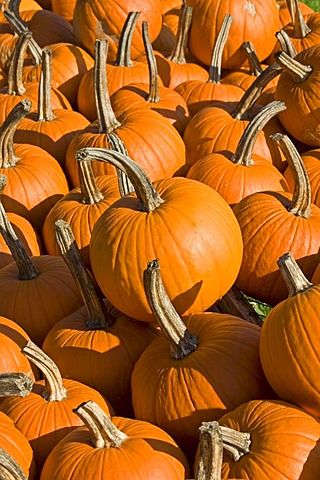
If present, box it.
[233,134,320,305]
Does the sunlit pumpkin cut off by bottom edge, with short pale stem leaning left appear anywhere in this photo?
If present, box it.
[40,401,190,480]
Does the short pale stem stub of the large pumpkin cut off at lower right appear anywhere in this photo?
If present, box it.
[277,252,313,297]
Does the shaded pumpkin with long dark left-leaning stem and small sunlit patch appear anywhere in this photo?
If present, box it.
[42,220,157,417]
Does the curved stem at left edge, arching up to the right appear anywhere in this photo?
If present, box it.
[0,98,31,168]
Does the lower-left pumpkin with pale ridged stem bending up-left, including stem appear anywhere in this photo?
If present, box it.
[0,342,113,475]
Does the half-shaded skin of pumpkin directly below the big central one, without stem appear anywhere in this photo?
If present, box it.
[132,312,271,459]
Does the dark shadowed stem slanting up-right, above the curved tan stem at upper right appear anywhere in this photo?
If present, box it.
[232,62,282,120]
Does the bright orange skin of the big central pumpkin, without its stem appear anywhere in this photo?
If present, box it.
[90,177,242,322]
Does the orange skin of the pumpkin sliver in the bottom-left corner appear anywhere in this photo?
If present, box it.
[0,412,36,480]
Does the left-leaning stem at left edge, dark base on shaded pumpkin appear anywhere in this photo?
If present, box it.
[0,175,39,280]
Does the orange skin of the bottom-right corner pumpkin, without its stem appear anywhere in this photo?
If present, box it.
[219,398,320,480]
